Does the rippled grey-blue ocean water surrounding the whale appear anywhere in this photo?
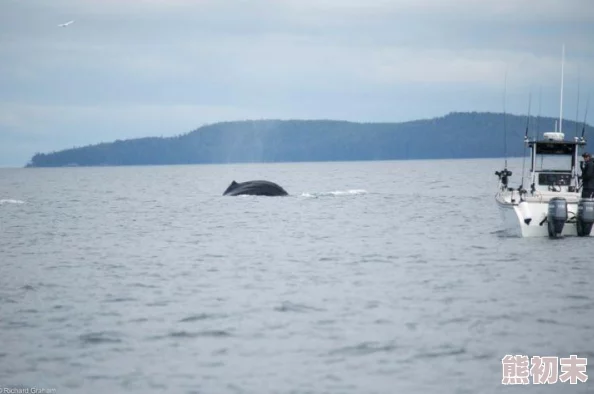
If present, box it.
[0,160,594,394]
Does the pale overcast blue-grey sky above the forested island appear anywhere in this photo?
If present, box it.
[0,0,594,166]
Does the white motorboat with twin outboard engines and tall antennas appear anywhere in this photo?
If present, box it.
[495,48,594,238]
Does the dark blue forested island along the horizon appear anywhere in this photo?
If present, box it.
[26,112,593,167]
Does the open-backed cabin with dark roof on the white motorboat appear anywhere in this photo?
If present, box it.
[525,132,586,193]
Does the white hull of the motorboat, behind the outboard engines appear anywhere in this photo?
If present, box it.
[495,193,594,237]
